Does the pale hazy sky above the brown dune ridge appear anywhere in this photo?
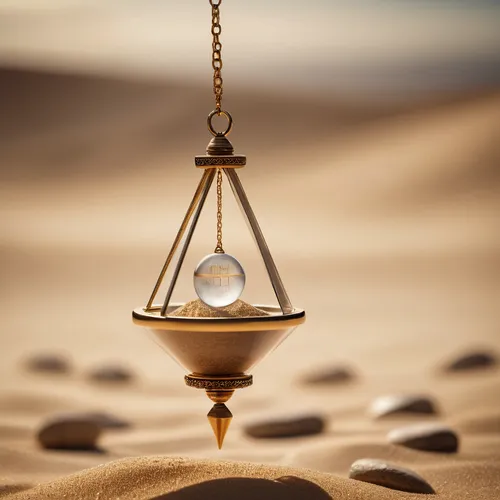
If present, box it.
[0,0,500,97]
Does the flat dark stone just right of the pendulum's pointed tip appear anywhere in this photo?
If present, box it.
[245,415,325,438]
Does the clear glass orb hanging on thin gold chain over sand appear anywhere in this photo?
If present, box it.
[194,253,245,307]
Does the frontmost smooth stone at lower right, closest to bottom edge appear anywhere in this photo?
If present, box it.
[349,458,435,493]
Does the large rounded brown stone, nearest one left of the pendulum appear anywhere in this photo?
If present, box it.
[37,414,102,450]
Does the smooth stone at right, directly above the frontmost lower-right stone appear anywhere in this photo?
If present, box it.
[387,423,459,453]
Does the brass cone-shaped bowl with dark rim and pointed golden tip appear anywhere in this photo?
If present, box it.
[133,304,305,449]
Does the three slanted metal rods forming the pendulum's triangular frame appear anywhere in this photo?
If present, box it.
[145,167,293,316]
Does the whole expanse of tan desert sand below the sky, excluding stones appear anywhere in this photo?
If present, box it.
[0,70,500,500]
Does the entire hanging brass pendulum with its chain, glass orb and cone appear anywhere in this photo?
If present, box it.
[133,0,305,448]
